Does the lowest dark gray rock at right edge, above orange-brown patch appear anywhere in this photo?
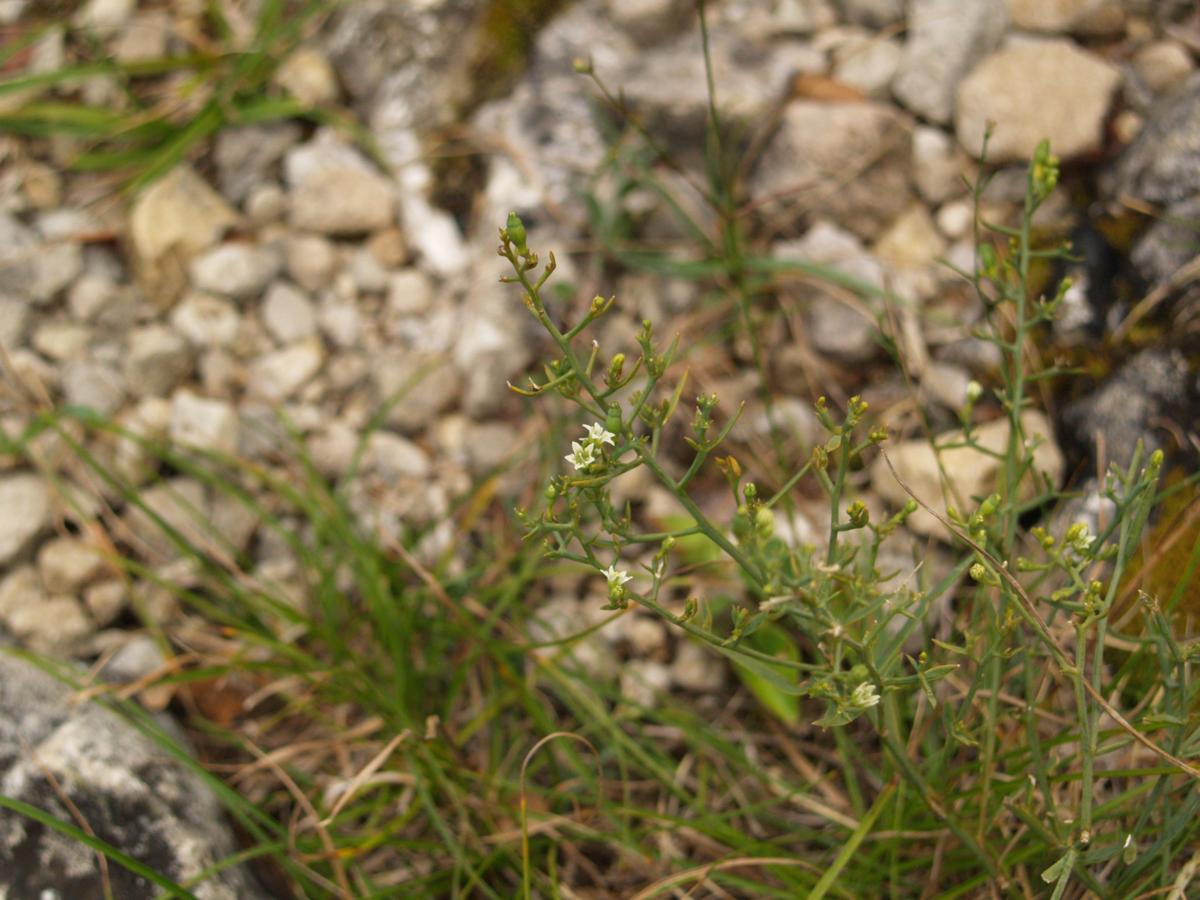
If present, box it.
[1063,349,1188,467]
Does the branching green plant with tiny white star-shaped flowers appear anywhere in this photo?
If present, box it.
[499,132,1200,898]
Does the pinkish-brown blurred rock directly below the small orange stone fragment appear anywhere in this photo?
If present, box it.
[750,101,912,239]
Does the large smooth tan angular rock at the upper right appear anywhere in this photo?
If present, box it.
[954,40,1121,162]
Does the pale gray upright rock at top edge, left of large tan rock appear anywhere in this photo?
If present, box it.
[892,0,1008,124]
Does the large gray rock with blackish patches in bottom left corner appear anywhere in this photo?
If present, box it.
[0,655,265,900]
